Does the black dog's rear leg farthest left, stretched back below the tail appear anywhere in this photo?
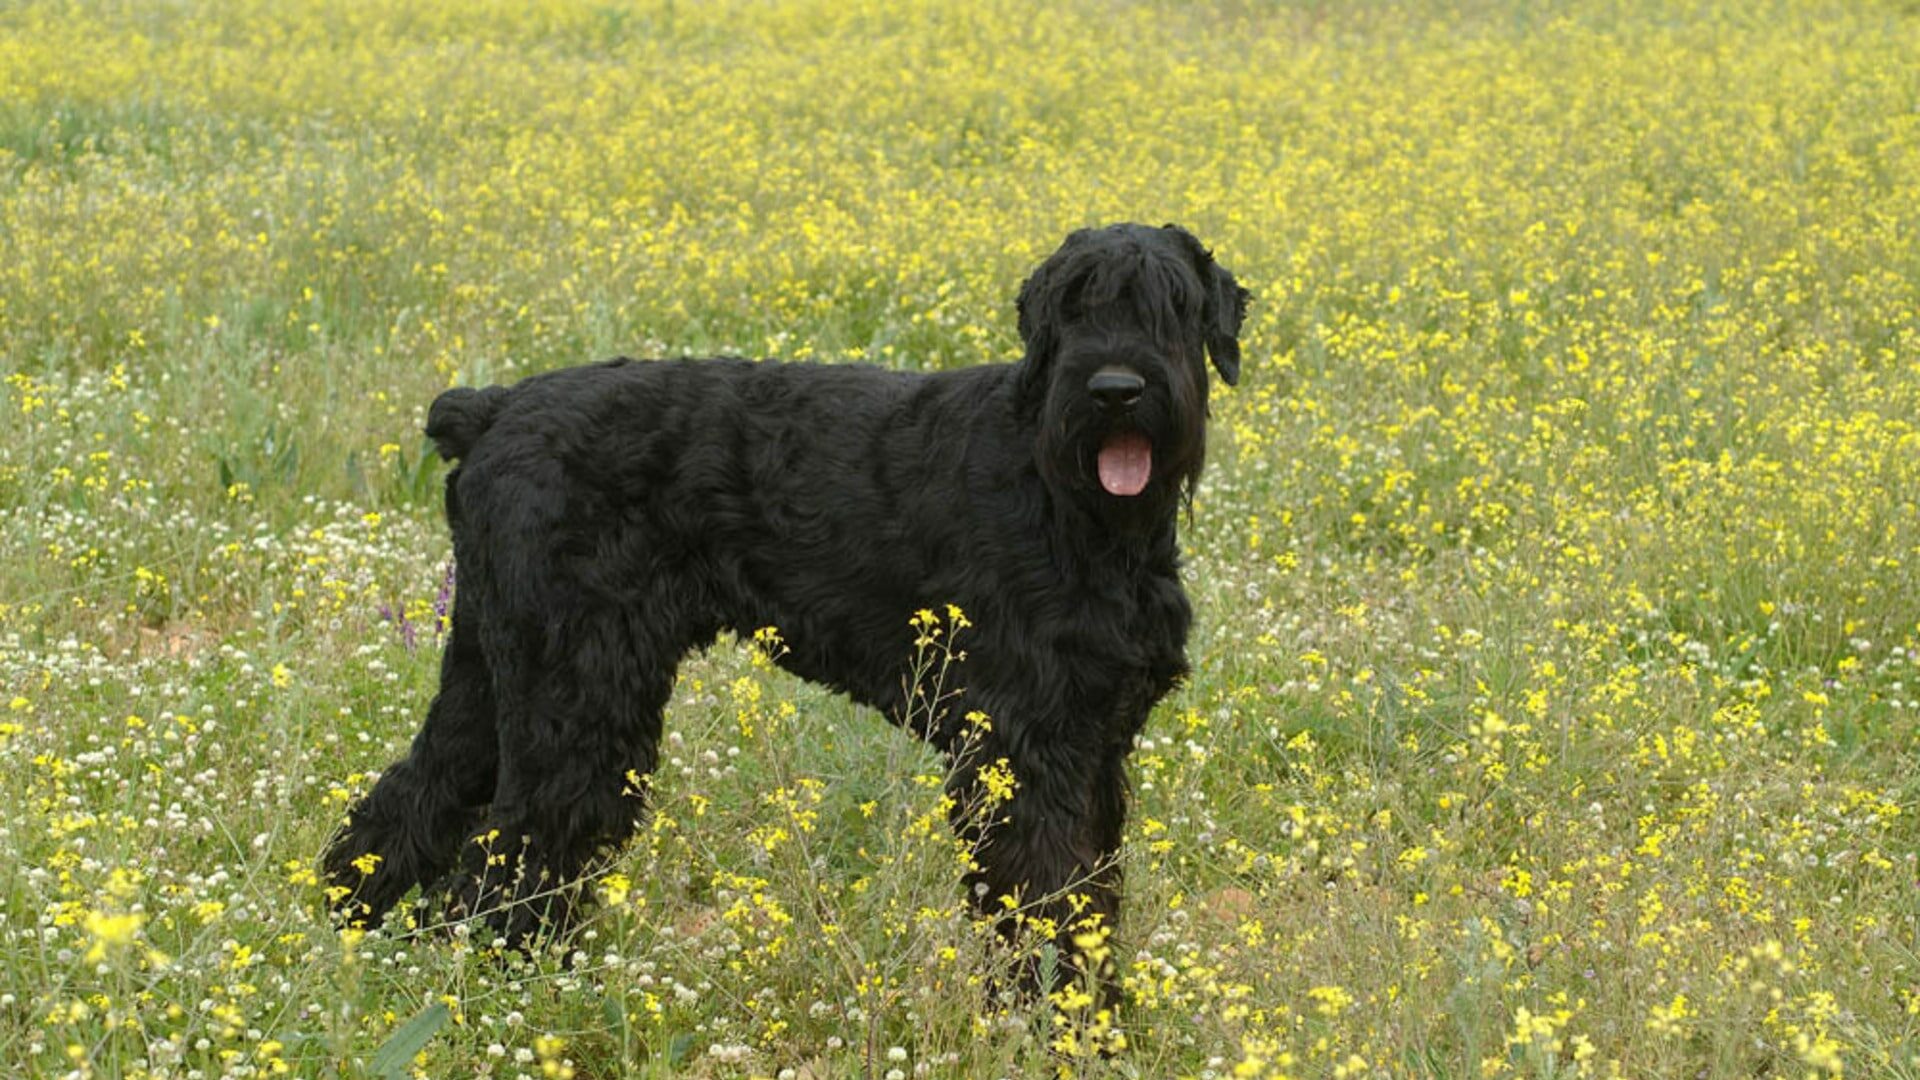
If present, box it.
[323,584,497,924]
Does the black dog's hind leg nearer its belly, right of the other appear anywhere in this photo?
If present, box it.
[449,607,682,947]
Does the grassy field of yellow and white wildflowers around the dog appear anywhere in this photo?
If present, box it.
[0,0,1920,1080]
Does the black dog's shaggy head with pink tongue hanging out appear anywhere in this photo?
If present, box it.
[1018,225,1248,517]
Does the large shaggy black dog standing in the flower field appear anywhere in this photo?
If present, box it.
[324,225,1248,991]
